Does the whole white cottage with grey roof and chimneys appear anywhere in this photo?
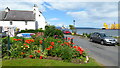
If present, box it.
[0,5,47,30]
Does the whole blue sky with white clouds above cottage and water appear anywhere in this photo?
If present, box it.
[0,0,119,28]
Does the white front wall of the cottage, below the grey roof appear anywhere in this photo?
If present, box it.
[0,21,35,30]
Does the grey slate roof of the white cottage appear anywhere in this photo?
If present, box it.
[0,10,35,21]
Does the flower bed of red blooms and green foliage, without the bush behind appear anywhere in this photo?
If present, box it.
[2,36,86,63]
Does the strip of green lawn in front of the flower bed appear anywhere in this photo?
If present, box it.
[2,59,101,68]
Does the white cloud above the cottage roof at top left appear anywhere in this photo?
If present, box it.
[0,0,45,11]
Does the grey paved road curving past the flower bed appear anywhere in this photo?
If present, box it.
[65,35,120,66]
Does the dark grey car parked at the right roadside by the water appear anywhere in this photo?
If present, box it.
[90,32,118,45]
